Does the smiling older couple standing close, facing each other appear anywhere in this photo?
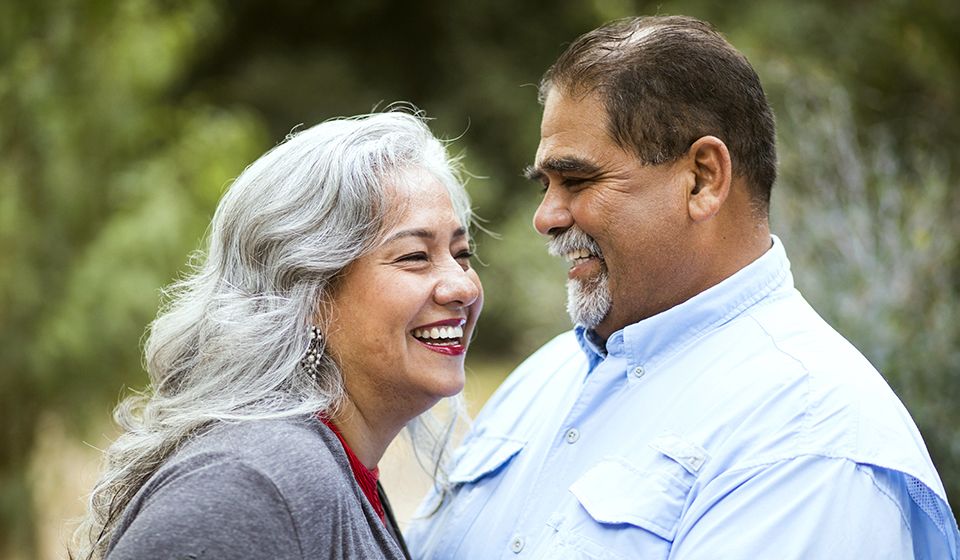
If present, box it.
[75,17,960,559]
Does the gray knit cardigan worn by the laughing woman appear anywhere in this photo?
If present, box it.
[107,418,405,560]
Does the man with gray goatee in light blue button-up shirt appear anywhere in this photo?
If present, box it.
[409,17,960,560]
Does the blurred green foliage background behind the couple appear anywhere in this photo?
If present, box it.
[0,0,960,559]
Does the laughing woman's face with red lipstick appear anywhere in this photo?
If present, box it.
[325,172,483,422]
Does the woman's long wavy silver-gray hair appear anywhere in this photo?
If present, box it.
[71,111,471,558]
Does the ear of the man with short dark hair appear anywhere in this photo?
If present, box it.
[687,136,733,222]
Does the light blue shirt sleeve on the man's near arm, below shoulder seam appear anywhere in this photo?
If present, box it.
[670,456,916,560]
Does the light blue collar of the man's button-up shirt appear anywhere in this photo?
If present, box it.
[575,235,793,371]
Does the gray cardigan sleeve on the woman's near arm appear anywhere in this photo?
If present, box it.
[107,461,302,560]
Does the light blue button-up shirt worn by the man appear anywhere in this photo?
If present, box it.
[407,238,960,560]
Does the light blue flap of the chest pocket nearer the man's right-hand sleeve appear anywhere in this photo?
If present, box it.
[570,458,693,541]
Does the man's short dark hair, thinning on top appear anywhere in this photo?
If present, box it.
[540,16,777,214]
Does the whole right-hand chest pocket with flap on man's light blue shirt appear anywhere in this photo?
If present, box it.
[570,435,709,557]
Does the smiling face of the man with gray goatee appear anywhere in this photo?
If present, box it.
[528,88,694,338]
